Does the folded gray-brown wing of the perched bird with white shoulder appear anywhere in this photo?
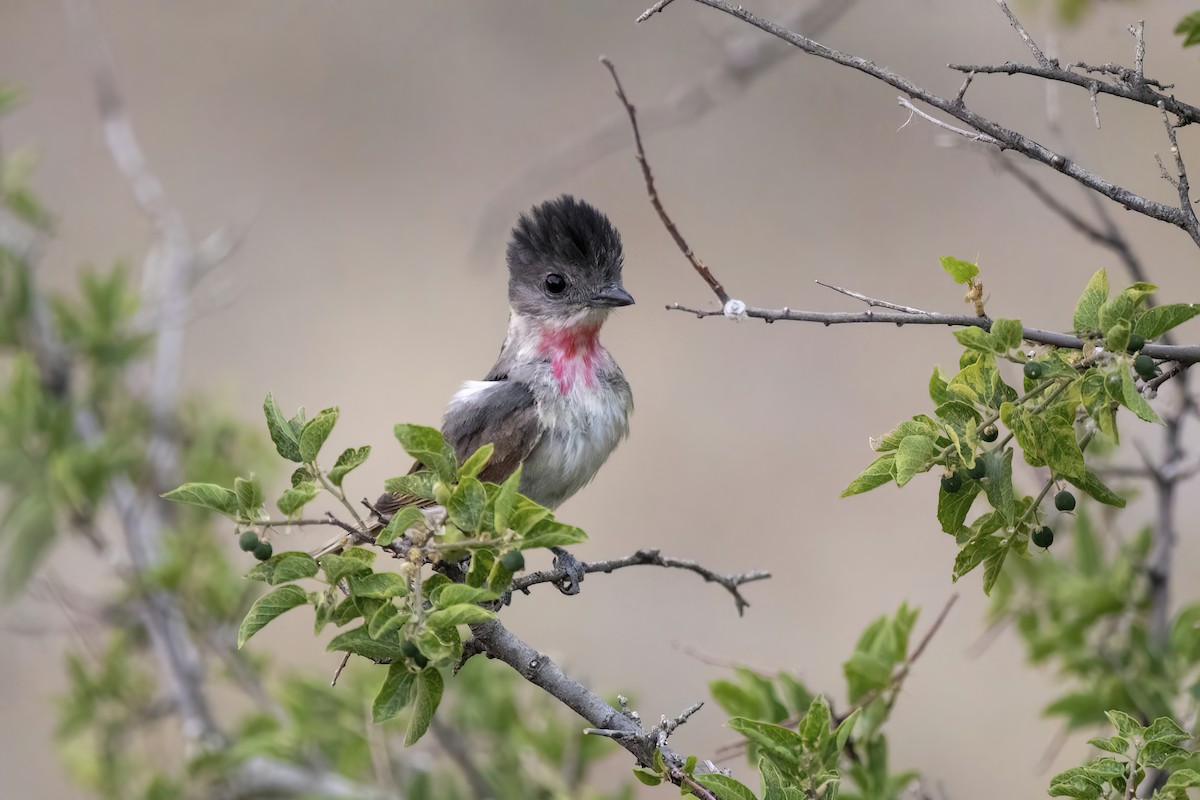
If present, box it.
[376,381,542,515]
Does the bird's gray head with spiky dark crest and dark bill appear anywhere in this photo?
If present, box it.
[508,194,634,318]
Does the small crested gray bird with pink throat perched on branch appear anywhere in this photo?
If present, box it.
[374,194,634,594]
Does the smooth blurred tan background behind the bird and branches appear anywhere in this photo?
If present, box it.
[0,0,1200,800]
